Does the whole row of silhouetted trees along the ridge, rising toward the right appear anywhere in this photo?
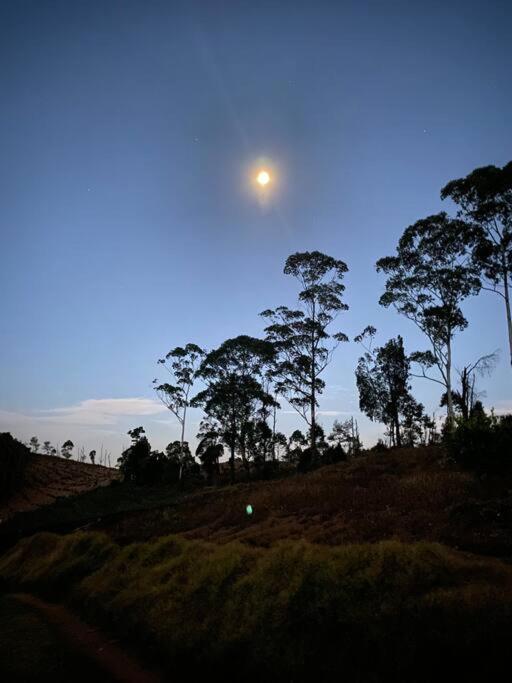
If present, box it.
[126,162,512,481]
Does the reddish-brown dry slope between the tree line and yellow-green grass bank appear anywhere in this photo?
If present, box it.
[5,447,512,558]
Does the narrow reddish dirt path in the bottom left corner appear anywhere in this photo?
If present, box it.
[13,593,166,683]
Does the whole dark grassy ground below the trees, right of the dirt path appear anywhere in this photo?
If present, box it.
[0,449,512,682]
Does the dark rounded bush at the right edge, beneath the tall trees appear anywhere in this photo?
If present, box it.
[446,411,512,474]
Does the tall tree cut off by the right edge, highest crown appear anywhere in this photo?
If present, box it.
[441,161,512,364]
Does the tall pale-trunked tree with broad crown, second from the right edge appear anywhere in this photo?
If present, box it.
[377,213,481,425]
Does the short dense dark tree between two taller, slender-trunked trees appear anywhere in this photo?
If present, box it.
[354,326,423,448]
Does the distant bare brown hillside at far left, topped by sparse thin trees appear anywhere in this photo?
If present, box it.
[0,454,120,521]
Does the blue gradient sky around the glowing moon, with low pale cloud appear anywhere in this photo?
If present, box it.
[0,0,512,456]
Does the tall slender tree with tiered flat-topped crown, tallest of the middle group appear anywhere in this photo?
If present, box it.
[261,251,348,453]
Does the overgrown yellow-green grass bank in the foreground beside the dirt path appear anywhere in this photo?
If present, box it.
[0,533,512,682]
